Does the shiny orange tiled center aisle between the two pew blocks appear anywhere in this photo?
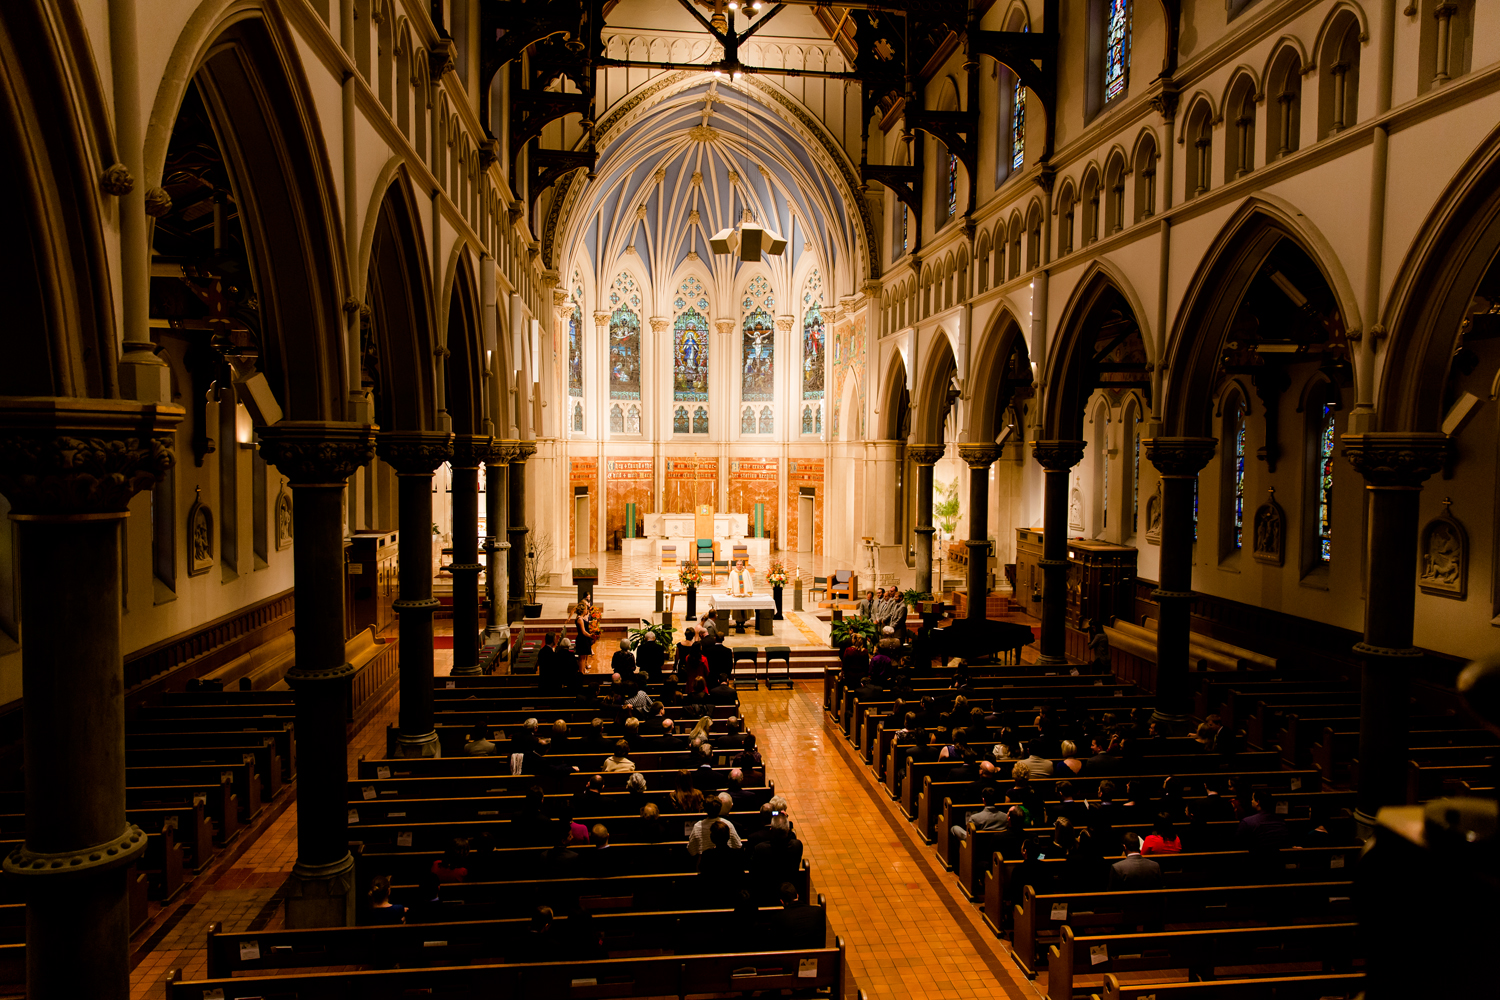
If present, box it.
[740,681,1041,1000]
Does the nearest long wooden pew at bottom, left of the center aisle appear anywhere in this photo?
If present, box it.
[167,937,846,1000]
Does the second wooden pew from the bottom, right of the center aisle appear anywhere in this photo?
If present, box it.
[1047,924,1359,1000]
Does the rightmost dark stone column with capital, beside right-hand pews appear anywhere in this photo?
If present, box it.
[1343,432,1448,834]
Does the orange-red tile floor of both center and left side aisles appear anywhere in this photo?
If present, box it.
[131,632,1043,1000]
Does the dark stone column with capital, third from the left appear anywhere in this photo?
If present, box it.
[375,430,453,757]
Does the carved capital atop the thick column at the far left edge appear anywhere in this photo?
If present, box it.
[0,396,185,519]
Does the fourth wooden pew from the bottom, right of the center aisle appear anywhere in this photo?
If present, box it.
[984,841,1361,934]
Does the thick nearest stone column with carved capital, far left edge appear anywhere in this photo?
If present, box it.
[0,396,183,1000]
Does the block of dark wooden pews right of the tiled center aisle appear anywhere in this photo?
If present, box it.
[824,664,1440,1000]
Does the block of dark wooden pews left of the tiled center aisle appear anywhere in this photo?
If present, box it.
[167,665,863,1000]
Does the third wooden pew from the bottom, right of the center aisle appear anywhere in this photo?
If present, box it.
[1011,882,1355,979]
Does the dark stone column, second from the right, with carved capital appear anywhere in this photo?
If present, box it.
[1145,438,1218,735]
